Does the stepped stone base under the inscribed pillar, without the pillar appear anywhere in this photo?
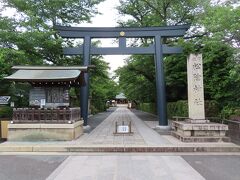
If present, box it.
[172,121,230,142]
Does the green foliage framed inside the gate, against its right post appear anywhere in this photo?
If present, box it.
[116,55,155,102]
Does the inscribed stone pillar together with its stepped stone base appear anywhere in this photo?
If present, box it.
[172,54,229,142]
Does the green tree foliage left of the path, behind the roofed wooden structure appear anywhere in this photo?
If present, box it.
[0,0,117,110]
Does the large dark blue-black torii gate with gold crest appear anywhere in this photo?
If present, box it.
[55,25,189,128]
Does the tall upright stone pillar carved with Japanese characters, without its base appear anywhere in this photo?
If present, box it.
[187,54,205,120]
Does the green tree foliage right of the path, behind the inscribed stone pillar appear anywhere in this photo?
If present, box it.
[116,0,240,112]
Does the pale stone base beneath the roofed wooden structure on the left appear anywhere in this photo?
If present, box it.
[7,121,83,141]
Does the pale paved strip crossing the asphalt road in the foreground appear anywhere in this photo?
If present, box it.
[47,155,204,180]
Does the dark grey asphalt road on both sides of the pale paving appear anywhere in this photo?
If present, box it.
[0,154,240,180]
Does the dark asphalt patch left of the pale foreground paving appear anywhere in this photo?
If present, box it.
[0,155,67,180]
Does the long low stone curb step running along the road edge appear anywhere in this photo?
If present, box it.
[0,145,240,153]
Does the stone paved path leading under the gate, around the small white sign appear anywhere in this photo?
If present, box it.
[77,107,171,146]
